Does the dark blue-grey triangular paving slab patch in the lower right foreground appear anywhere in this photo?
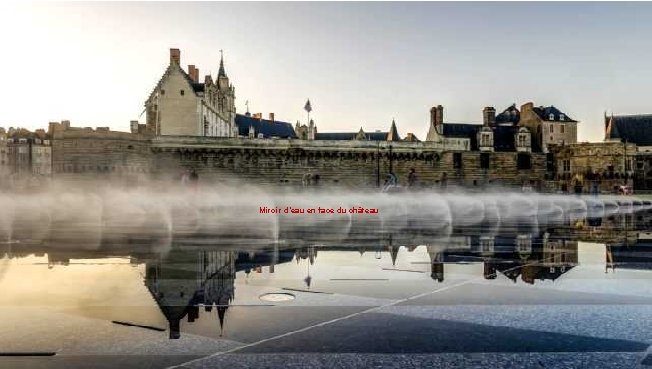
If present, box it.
[228,313,649,354]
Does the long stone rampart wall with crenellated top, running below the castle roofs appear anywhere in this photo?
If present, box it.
[152,138,546,187]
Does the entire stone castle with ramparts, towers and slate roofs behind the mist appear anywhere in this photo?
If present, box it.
[5,49,652,192]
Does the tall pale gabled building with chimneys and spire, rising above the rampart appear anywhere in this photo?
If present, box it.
[144,49,238,137]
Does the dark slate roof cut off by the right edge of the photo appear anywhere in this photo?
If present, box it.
[605,114,652,146]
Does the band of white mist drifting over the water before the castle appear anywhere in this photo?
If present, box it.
[0,185,652,252]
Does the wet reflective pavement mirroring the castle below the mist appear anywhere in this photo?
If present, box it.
[0,191,652,368]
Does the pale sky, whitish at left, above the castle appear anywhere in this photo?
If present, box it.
[0,2,652,141]
